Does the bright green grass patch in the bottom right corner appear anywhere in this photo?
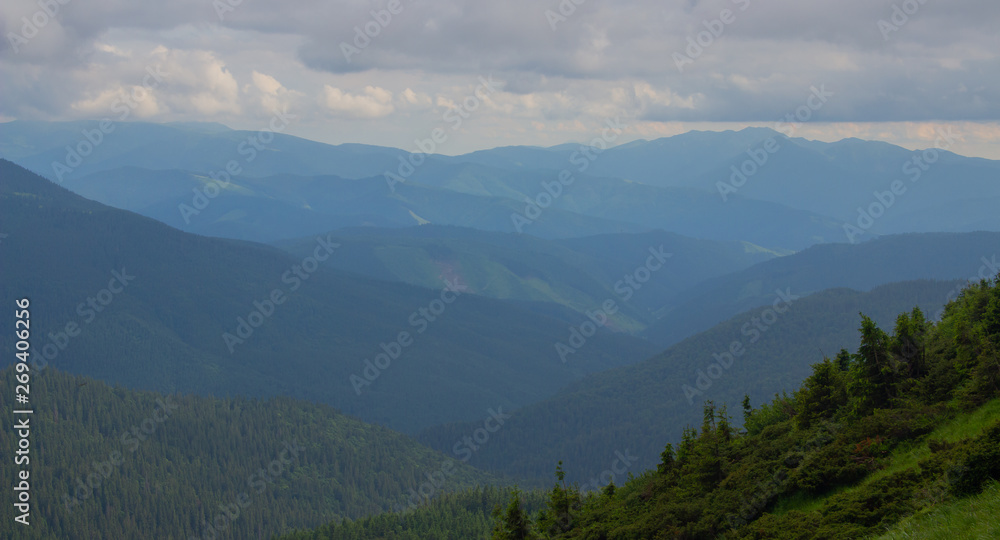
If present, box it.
[878,482,1000,540]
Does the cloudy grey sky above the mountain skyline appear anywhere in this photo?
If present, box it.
[0,0,1000,159]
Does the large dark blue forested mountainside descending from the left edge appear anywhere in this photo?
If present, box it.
[0,162,655,432]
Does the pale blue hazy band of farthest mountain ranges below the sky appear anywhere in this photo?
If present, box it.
[7,122,1000,250]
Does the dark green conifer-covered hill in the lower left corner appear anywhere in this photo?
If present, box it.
[0,367,497,540]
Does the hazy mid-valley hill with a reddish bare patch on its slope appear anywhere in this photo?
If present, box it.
[275,225,776,332]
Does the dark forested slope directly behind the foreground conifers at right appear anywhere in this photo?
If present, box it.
[420,281,962,483]
